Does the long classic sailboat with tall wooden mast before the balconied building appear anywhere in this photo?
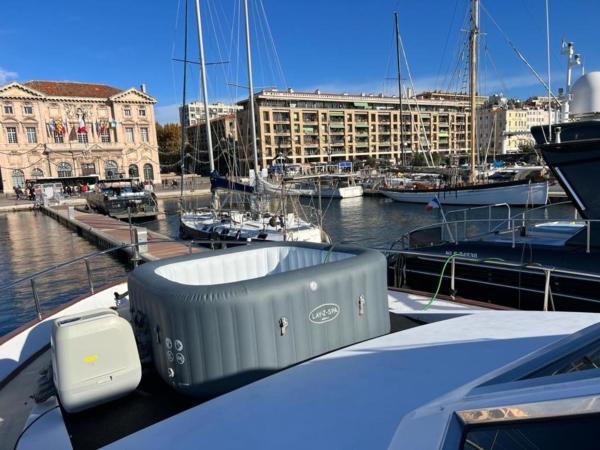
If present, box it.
[380,0,548,206]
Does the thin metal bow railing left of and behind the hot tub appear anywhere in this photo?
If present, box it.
[0,239,246,320]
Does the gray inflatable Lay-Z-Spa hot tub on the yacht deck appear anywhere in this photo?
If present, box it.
[128,243,390,397]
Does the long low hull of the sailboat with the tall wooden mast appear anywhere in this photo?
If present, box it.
[380,181,548,206]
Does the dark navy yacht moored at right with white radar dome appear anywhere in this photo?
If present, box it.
[396,67,600,312]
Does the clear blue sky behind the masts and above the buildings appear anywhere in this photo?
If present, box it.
[0,0,600,122]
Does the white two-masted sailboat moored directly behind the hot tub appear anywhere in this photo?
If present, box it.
[179,0,329,243]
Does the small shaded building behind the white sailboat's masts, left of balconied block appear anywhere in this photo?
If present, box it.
[185,114,238,175]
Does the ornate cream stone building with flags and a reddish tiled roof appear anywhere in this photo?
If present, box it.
[0,81,160,192]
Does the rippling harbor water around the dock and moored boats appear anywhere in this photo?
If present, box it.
[0,195,573,336]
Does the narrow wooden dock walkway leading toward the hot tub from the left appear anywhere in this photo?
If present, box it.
[42,207,203,261]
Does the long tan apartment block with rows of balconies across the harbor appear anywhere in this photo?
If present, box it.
[238,89,476,167]
